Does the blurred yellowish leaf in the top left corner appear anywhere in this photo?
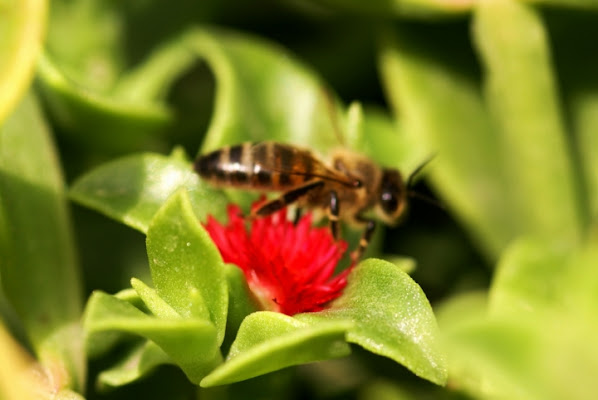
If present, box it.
[0,0,48,125]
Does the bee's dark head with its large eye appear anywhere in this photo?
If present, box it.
[377,169,407,225]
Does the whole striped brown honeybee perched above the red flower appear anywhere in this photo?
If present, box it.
[194,141,423,261]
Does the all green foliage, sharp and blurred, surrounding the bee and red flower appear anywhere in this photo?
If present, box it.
[0,0,598,400]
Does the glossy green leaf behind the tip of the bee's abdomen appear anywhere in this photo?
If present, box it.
[70,153,227,233]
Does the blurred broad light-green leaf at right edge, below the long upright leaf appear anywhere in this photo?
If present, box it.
[489,232,598,320]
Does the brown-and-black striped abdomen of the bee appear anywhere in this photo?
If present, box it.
[194,142,327,191]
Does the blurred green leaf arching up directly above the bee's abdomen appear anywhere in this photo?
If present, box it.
[186,29,346,152]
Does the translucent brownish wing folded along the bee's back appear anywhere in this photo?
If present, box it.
[251,142,355,186]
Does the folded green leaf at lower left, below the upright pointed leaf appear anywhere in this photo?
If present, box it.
[83,292,221,383]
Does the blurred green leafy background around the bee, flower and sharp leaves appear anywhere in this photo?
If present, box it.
[0,0,598,399]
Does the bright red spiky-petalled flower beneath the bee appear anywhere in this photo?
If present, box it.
[205,205,350,315]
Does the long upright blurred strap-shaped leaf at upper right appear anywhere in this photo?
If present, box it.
[474,0,583,241]
